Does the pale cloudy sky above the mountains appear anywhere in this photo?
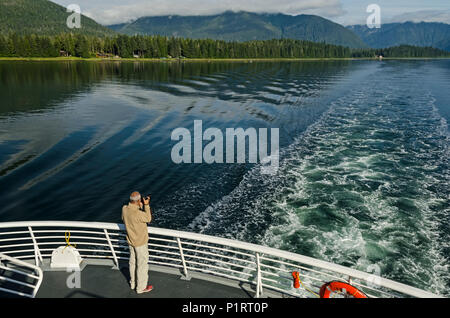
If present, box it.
[52,0,450,25]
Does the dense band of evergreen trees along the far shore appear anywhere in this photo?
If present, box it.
[0,33,450,59]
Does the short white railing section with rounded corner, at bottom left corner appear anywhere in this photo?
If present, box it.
[0,253,43,298]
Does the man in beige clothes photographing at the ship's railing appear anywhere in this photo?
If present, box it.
[122,192,153,294]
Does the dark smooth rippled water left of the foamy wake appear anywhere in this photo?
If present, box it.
[0,61,357,227]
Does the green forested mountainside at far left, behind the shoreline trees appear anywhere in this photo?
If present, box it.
[0,0,115,36]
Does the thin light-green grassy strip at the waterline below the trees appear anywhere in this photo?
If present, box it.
[0,57,450,63]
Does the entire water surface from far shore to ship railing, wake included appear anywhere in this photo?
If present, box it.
[0,60,450,295]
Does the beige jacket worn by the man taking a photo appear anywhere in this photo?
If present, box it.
[122,203,152,247]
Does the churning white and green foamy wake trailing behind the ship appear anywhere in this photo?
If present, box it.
[191,63,450,295]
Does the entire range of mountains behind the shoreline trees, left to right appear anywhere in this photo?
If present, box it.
[0,0,450,52]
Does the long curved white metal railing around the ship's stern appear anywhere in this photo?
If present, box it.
[0,221,440,298]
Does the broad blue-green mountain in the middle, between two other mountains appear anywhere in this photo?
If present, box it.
[109,11,367,48]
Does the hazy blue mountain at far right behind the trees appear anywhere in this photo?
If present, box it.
[348,22,450,51]
